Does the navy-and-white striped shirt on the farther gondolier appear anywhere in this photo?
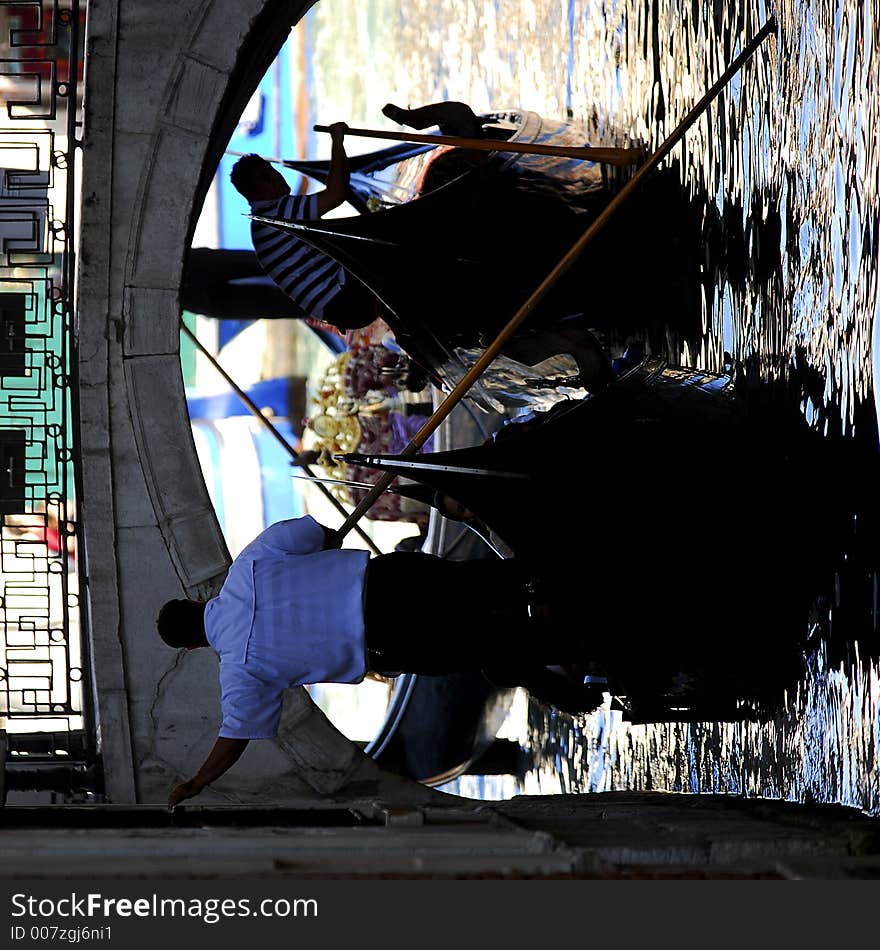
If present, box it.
[251,195,345,320]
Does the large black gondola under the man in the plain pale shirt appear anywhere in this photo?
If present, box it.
[345,358,876,718]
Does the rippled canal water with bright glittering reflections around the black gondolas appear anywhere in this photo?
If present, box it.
[305,0,880,815]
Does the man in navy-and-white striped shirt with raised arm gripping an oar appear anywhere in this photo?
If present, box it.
[230,122,377,330]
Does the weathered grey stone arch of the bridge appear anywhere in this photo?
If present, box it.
[77,0,436,803]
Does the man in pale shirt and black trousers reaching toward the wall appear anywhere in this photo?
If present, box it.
[157,516,569,807]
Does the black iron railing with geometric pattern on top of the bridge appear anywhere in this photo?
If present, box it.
[0,0,91,788]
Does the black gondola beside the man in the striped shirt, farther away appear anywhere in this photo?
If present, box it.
[260,111,703,382]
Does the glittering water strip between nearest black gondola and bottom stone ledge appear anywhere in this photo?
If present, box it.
[516,653,880,814]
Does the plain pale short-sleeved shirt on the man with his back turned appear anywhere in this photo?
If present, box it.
[205,516,369,739]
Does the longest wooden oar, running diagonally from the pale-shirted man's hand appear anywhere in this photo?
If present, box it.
[326,17,776,538]
